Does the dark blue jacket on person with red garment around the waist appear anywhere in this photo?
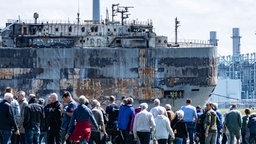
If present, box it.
[68,104,99,134]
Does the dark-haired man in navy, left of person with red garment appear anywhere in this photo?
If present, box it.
[61,91,77,144]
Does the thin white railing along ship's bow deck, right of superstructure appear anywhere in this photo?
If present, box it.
[168,40,214,48]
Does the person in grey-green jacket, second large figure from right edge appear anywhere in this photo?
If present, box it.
[225,104,242,144]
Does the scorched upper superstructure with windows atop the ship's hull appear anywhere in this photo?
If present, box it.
[2,15,168,48]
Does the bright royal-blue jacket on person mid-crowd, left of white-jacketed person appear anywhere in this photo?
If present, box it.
[117,105,135,130]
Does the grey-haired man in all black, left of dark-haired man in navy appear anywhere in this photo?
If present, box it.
[45,93,62,144]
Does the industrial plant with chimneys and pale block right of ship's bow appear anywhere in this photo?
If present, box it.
[209,28,256,107]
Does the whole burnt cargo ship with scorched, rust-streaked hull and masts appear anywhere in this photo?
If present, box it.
[0,1,217,109]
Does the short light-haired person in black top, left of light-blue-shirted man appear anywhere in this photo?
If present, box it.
[173,110,188,144]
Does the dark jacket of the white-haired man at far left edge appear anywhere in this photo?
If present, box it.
[0,100,18,131]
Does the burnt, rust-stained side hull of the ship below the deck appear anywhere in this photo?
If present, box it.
[0,47,217,108]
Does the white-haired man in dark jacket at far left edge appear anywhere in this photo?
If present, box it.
[0,93,20,144]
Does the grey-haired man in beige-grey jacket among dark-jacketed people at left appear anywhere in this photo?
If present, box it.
[17,91,28,144]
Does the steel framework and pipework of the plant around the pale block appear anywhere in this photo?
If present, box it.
[218,53,256,99]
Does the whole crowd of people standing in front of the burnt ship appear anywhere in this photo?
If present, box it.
[0,87,256,144]
